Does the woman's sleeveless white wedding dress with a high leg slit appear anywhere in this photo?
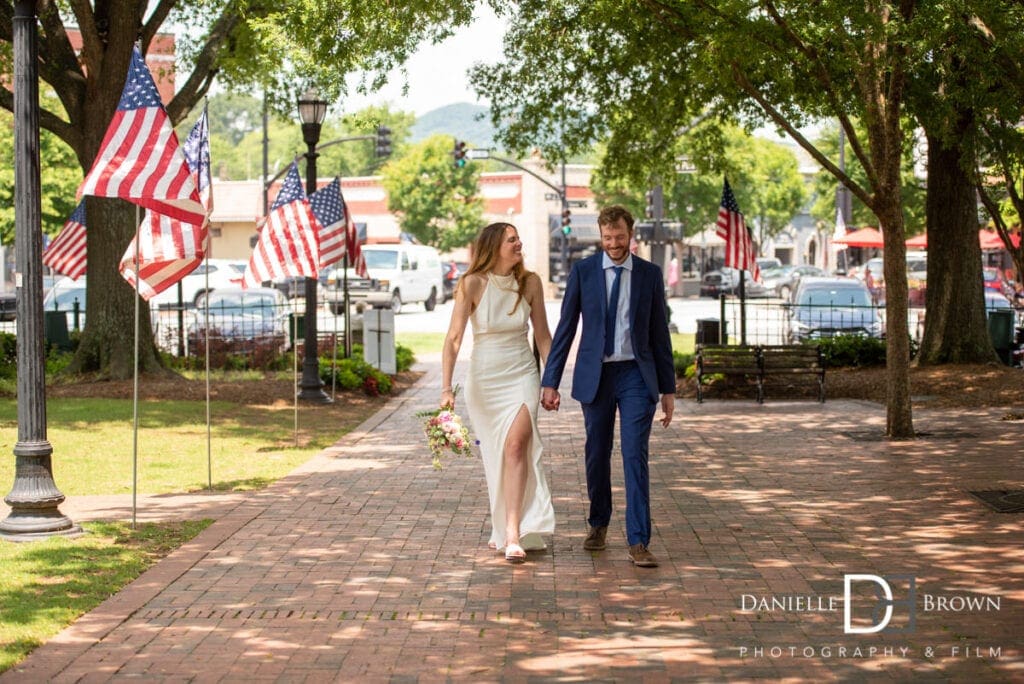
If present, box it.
[466,273,555,550]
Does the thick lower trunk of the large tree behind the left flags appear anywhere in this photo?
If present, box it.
[68,198,161,380]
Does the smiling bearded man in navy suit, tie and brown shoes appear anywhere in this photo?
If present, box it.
[541,206,676,567]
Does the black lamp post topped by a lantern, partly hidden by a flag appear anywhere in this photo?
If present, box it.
[299,89,331,403]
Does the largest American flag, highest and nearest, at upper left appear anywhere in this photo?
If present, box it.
[78,45,206,225]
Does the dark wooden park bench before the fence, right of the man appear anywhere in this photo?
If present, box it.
[696,344,825,403]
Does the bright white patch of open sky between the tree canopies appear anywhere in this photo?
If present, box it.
[343,6,505,117]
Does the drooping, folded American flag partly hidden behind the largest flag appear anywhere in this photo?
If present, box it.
[120,110,213,301]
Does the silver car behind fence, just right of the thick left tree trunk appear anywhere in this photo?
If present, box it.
[188,288,291,350]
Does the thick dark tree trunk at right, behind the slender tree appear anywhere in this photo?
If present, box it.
[918,135,998,366]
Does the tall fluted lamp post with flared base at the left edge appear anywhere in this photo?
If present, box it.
[0,0,82,541]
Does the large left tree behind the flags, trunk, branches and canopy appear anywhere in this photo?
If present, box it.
[0,0,473,378]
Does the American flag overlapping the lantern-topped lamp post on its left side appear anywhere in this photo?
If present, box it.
[243,162,321,288]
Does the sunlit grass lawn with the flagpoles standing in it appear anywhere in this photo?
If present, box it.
[0,398,362,496]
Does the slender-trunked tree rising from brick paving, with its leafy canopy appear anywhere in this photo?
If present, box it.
[472,0,927,436]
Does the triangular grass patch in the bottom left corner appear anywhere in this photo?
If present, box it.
[0,520,212,672]
